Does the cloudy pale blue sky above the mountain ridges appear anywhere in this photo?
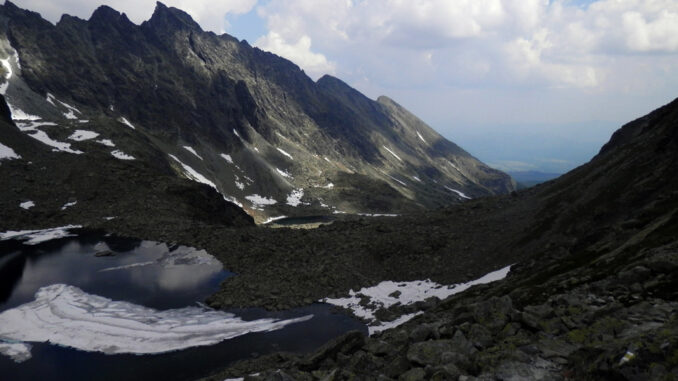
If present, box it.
[9,0,678,173]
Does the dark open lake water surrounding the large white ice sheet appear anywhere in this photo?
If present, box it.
[0,229,367,380]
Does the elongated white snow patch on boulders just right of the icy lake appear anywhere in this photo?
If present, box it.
[321,266,511,335]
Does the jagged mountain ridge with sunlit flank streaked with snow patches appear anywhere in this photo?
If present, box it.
[0,1,513,221]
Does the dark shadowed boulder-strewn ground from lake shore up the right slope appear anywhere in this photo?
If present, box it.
[0,93,678,380]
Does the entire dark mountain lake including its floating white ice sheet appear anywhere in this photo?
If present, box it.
[0,227,367,380]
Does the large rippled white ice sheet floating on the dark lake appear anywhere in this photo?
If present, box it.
[0,284,313,354]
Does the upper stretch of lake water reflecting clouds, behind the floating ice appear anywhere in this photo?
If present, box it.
[0,235,231,311]
